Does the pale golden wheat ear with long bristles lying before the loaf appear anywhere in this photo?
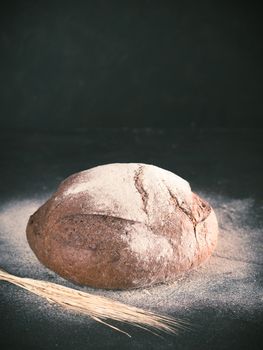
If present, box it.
[0,269,187,337]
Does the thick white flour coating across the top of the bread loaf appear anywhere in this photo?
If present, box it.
[60,163,192,224]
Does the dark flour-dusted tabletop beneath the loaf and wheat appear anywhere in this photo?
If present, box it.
[0,128,263,350]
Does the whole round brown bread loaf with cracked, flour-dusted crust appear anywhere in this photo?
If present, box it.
[27,163,218,289]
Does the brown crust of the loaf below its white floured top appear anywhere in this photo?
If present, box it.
[27,164,218,289]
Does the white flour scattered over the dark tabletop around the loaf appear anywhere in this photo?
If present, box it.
[0,192,263,318]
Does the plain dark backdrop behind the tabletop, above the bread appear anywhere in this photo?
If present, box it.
[0,0,263,130]
